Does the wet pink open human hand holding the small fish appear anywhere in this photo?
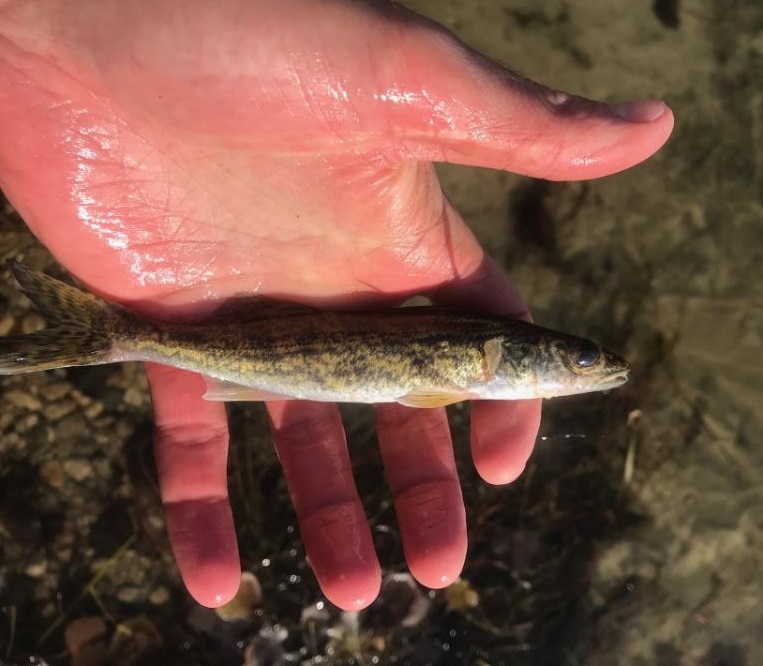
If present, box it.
[0,0,673,609]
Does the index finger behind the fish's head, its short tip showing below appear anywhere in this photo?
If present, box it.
[430,252,542,484]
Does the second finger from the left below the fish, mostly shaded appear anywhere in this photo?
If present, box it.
[267,400,381,610]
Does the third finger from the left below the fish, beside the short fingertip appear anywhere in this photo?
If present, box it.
[376,404,467,588]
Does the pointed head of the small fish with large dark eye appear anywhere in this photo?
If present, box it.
[496,332,630,398]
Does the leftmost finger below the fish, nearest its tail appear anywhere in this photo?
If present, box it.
[146,363,241,607]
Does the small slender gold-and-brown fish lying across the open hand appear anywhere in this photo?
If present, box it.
[0,261,630,408]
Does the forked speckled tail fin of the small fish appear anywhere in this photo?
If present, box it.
[0,261,118,375]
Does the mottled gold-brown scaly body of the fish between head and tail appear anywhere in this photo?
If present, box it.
[118,308,532,395]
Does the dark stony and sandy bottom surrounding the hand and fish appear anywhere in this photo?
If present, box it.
[0,0,763,666]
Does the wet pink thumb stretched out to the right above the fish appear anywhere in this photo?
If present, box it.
[376,13,673,180]
